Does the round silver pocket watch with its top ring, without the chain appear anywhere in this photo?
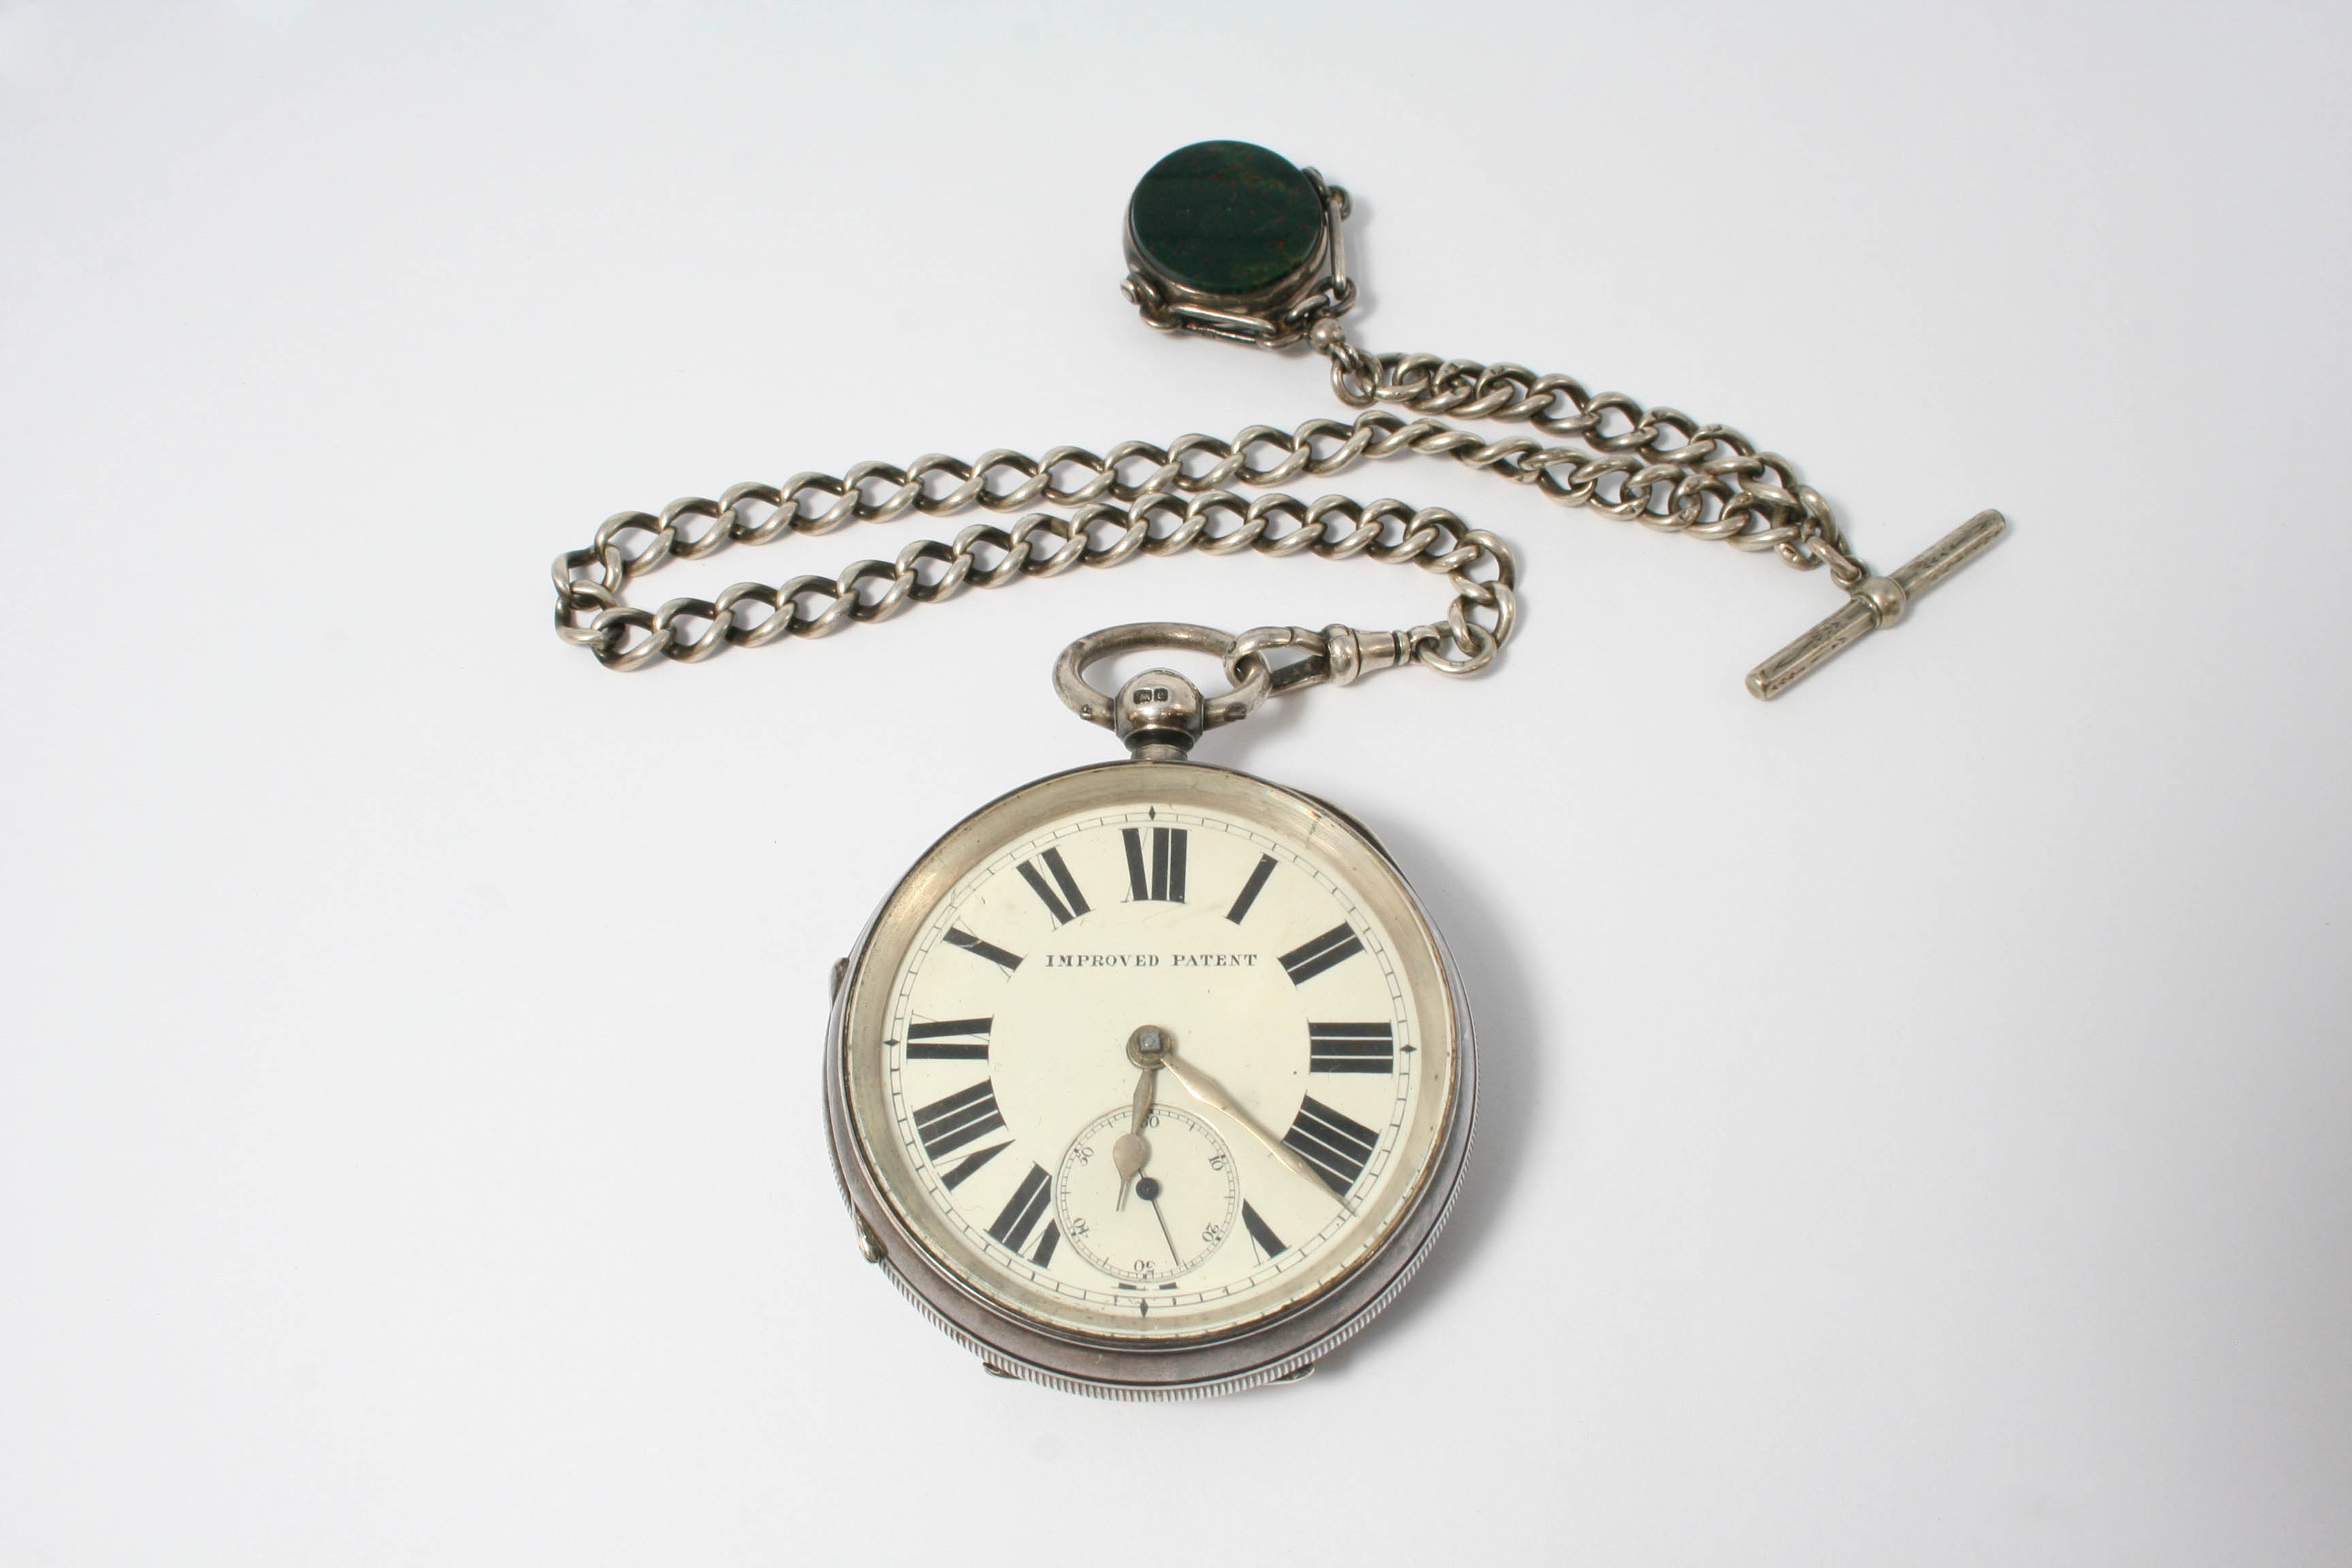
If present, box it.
[826,625,1475,1396]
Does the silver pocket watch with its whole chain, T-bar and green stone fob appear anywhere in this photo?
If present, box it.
[555,141,2006,1399]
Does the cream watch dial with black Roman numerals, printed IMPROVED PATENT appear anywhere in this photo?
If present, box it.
[851,769,1454,1340]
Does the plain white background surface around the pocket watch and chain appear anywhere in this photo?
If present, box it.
[0,0,2352,1566]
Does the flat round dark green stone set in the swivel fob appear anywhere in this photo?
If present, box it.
[1126,141,1324,296]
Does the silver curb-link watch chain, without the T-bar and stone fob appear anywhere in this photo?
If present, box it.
[553,327,1865,689]
